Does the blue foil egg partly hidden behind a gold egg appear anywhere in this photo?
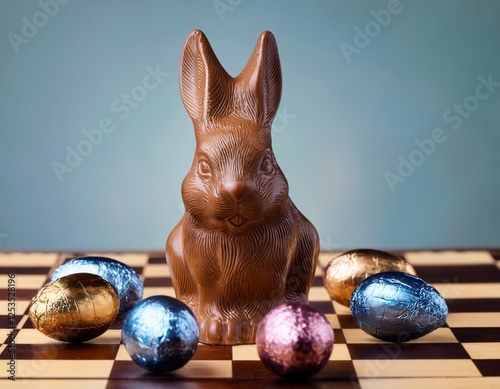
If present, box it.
[50,257,144,316]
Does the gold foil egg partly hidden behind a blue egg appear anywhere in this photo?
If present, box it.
[324,249,417,307]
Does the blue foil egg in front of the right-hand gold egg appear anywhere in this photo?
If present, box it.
[350,272,448,343]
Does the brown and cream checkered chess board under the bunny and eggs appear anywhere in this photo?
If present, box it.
[0,251,500,389]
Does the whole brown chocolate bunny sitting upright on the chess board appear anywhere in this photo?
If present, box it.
[166,30,319,344]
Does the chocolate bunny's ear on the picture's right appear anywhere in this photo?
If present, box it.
[235,31,282,127]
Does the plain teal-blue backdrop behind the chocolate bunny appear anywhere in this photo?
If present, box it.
[0,0,500,251]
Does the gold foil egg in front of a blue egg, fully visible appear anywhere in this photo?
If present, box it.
[29,273,120,343]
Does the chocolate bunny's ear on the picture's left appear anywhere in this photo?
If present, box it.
[180,30,231,124]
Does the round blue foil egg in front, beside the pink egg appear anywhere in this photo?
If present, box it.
[122,296,200,373]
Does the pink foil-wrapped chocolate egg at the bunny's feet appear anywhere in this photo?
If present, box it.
[256,303,334,377]
